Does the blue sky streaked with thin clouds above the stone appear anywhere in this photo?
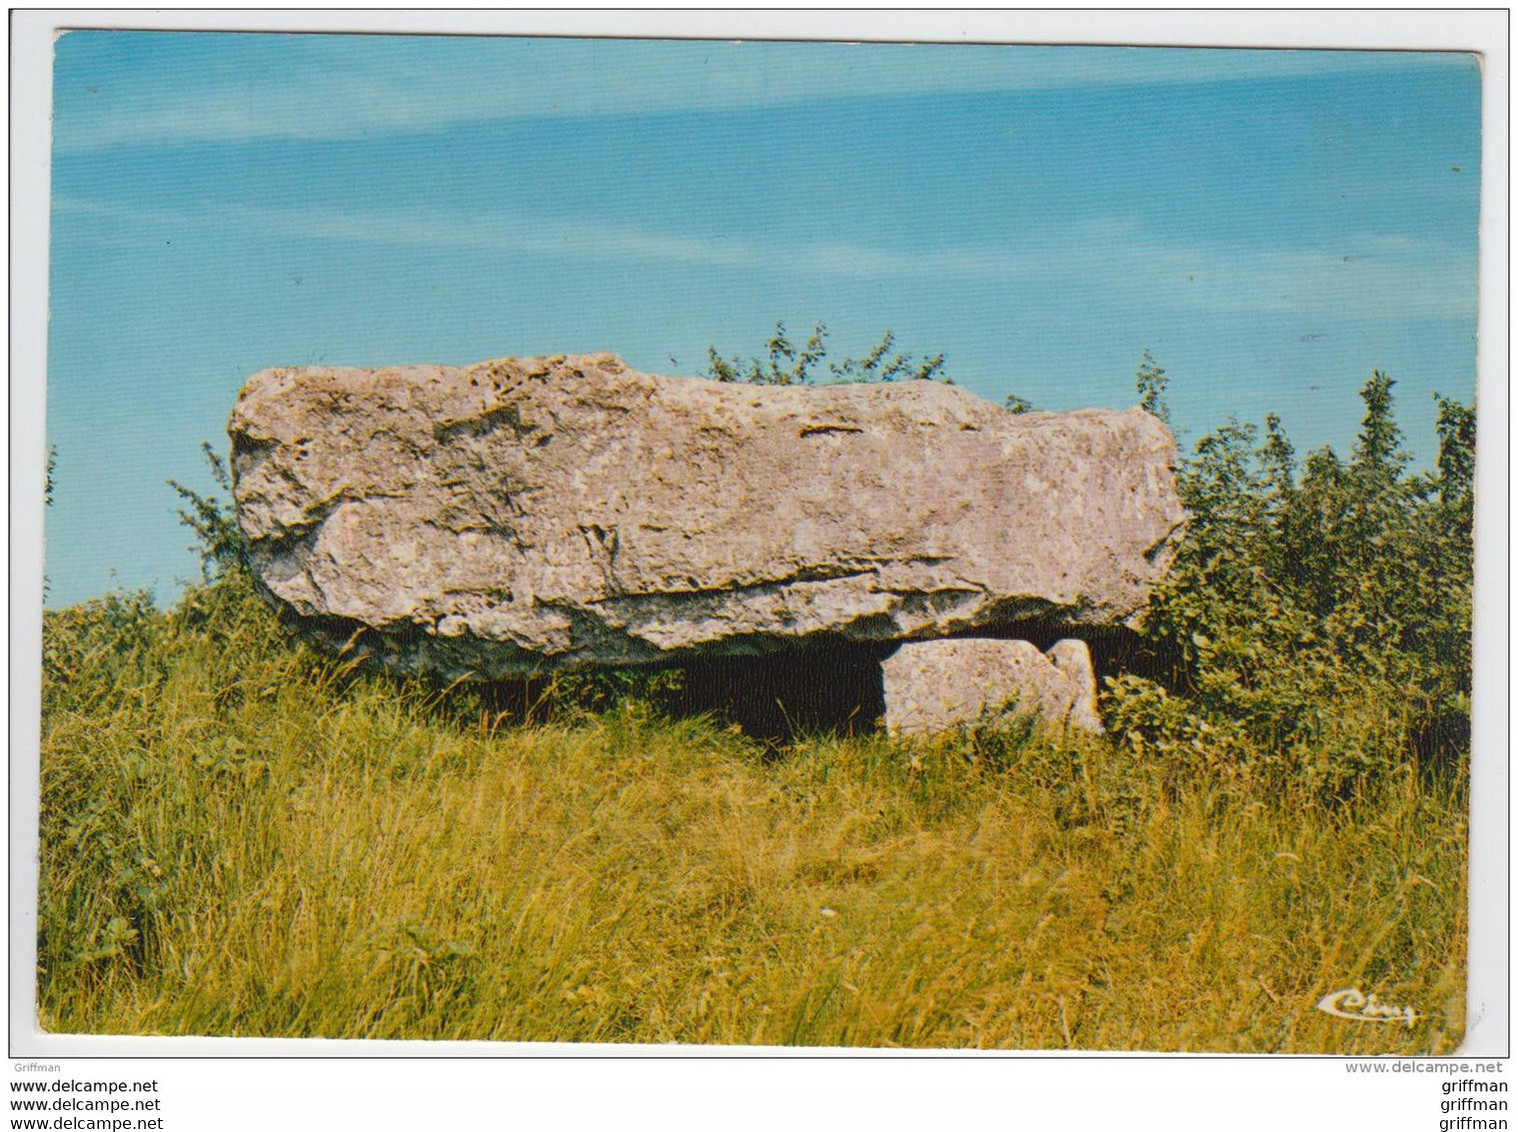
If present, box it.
[47,32,1480,605]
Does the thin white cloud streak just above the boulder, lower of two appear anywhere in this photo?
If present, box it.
[55,199,1475,320]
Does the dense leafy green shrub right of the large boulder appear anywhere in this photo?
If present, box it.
[1105,364,1475,795]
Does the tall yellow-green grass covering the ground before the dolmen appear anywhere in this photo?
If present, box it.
[38,580,1466,1055]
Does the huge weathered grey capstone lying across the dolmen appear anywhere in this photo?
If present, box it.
[228,355,1184,678]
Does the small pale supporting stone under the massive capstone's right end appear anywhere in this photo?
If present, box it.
[880,640,1102,734]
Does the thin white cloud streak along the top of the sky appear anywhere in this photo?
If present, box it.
[55,32,1463,153]
